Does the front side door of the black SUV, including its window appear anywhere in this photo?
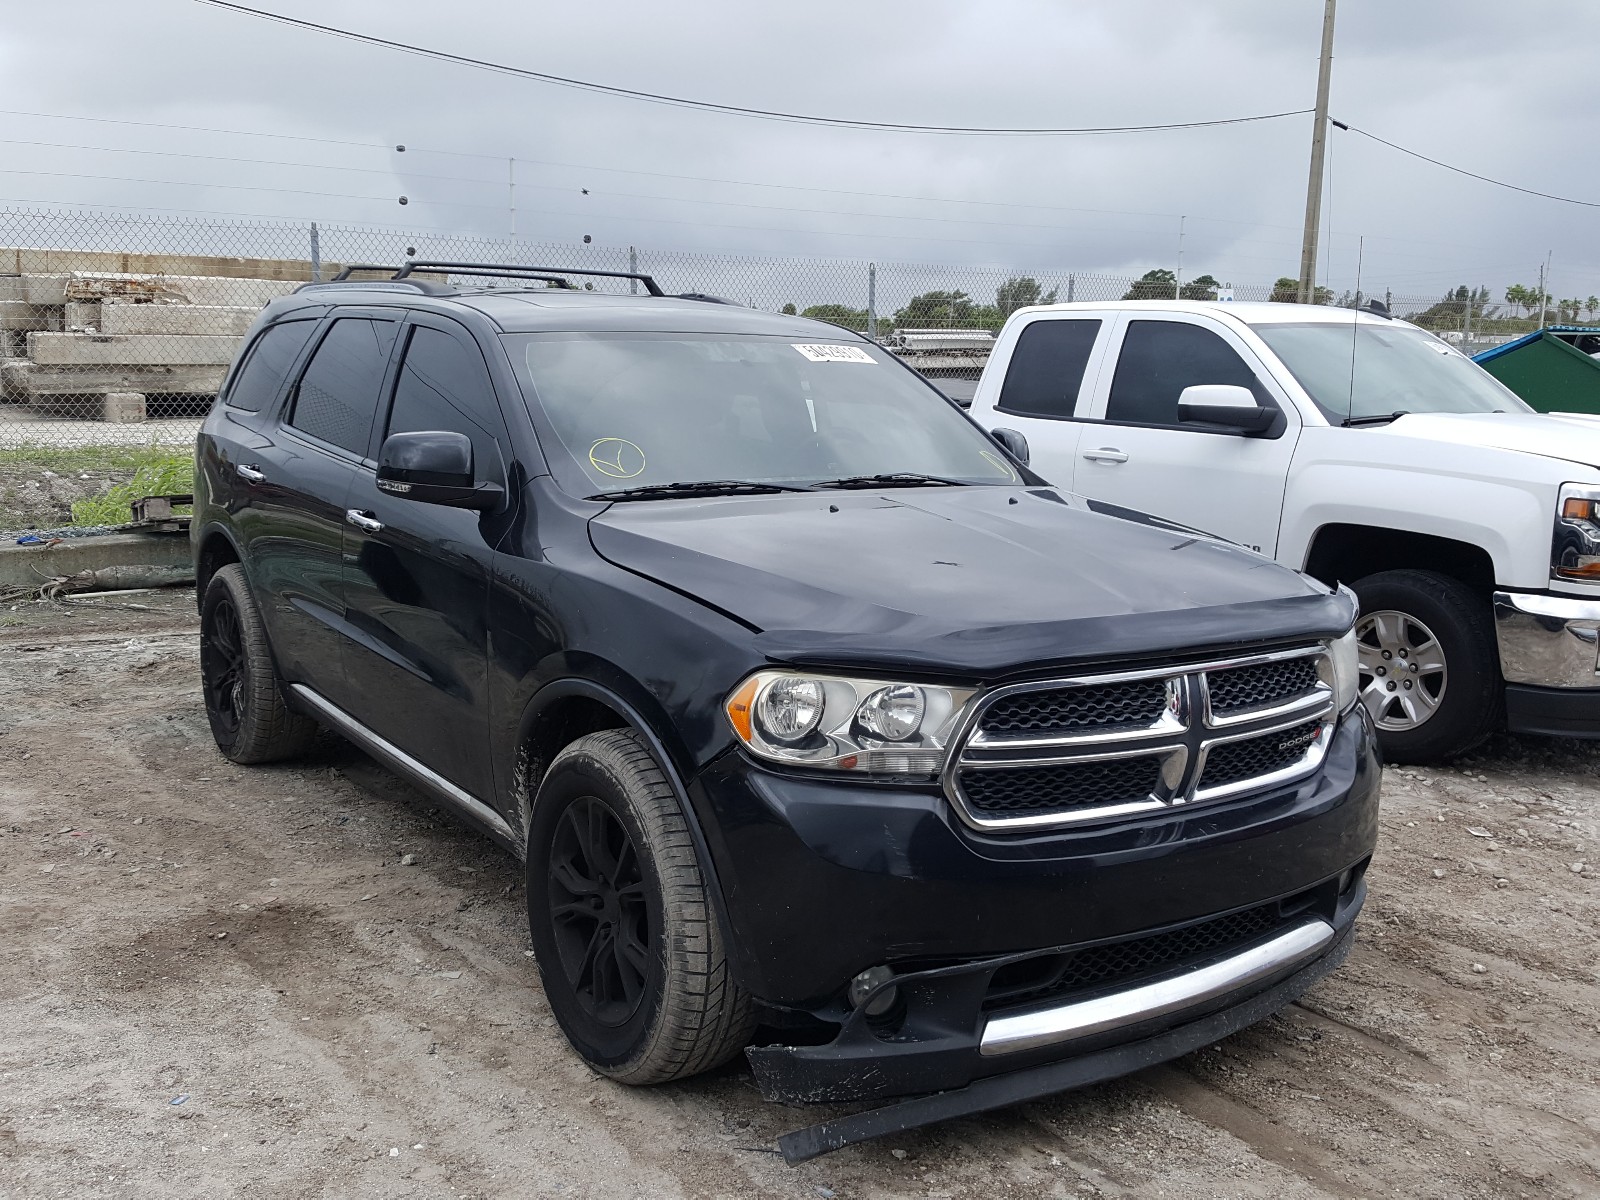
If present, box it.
[344,314,510,802]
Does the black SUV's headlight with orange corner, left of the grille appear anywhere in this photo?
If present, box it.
[725,670,973,778]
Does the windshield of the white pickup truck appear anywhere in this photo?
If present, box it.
[1250,320,1533,424]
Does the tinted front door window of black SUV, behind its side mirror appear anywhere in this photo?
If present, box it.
[389,325,504,482]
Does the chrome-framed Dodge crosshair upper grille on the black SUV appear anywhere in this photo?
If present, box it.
[944,646,1333,832]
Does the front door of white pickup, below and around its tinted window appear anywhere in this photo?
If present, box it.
[1072,314,1301,555]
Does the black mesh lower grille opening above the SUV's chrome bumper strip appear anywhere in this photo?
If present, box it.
[984,902,1283,1008]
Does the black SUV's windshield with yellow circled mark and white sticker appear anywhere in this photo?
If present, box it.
[506,333,1019,496]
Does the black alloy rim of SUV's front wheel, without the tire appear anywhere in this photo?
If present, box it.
[549,795,661,1029]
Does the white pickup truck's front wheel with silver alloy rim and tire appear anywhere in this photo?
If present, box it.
[1352,570,1504,763]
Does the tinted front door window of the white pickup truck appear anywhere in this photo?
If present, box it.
[1106,322,1277,426]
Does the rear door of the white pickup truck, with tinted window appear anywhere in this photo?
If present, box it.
[971,310,1114,490]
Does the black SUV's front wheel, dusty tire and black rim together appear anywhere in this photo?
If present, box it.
[526,730,755,1085]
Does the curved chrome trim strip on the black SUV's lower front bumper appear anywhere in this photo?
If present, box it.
[979,920,1333,1054]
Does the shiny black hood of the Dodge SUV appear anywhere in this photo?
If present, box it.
[589,486,1354,678]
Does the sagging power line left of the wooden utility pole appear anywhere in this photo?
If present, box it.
[195,0,1310,138]
